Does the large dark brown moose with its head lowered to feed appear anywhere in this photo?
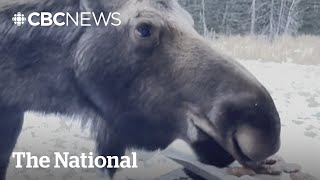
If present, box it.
[0,0,280,180]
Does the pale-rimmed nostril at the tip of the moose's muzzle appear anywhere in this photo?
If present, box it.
[235,126,280,161]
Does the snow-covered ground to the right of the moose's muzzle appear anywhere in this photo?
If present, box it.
[242,61,320,179]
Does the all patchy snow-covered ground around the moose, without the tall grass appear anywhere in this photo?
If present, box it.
[8,61,320,180]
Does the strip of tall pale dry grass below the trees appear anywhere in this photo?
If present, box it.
[211,35,320,65]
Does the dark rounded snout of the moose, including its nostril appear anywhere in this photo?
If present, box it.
[209,89,281,164]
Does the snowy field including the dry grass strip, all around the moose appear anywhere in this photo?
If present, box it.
[3,36,320,180]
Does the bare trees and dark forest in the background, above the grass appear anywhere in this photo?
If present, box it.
[179,0,320,38]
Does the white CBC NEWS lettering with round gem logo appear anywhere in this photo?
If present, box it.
[12,12,121,26]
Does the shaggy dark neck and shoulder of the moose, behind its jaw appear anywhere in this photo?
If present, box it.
[0,0,96,114]
